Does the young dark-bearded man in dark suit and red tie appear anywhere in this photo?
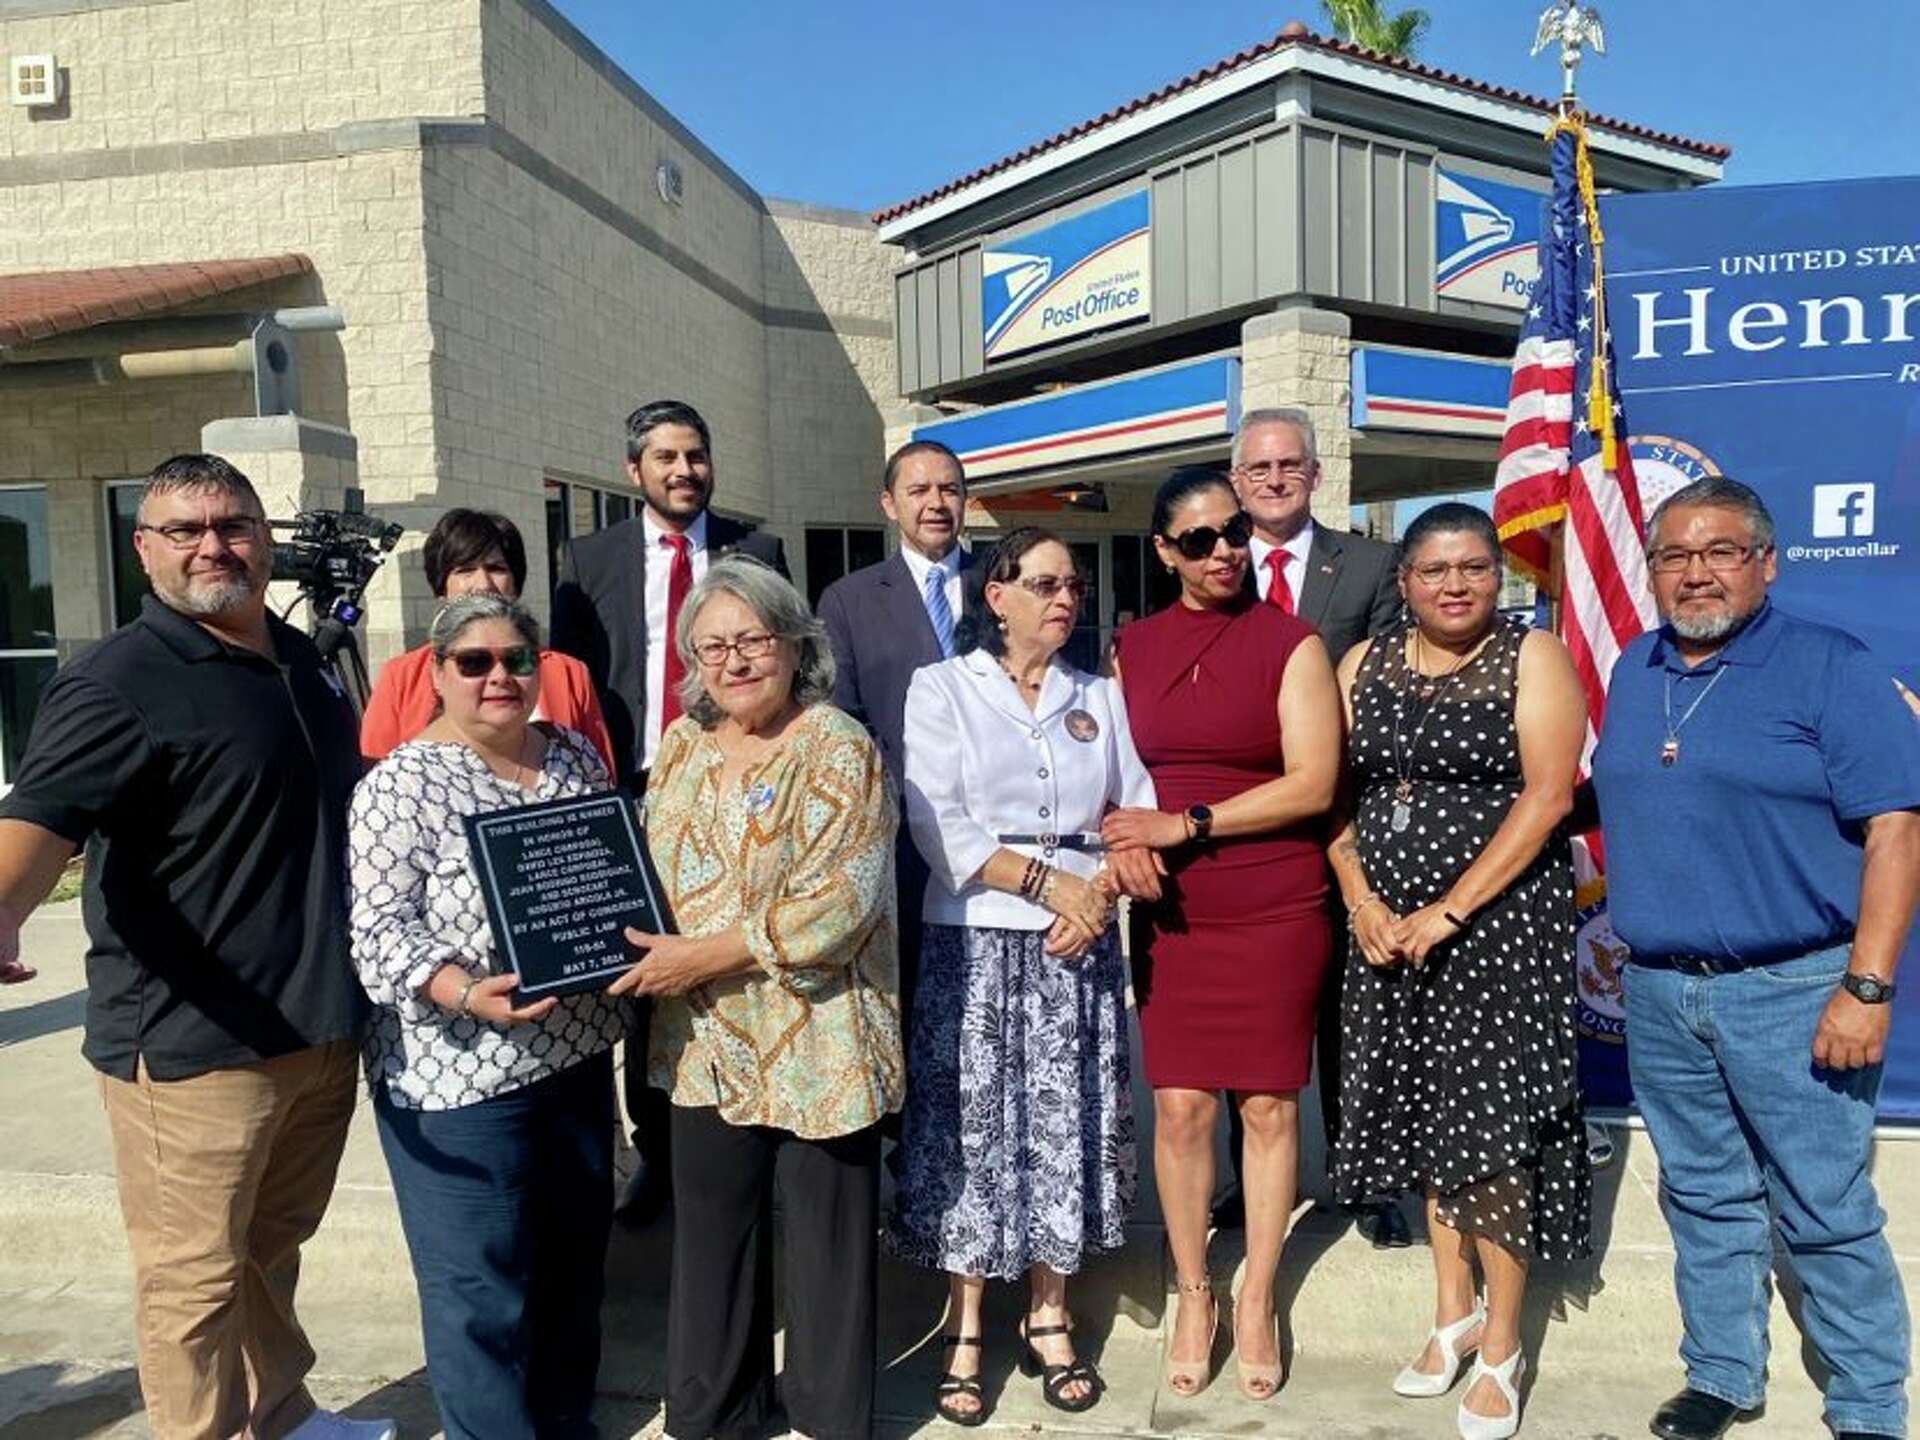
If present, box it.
[553,399,787,1225]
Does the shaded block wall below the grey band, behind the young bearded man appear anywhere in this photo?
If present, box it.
[426,146,772,609]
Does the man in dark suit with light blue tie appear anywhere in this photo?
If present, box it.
[820,440,973,1023]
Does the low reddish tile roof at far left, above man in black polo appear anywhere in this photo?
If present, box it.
[0,255,313,346]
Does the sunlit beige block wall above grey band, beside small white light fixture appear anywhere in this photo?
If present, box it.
[0,0,482,156]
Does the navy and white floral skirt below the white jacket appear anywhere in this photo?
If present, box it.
[889,925,1137,1279]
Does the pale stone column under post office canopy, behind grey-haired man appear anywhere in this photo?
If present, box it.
[1240,305,1354,532]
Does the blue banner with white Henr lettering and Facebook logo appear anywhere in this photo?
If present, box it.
[1599,179,1920,1121]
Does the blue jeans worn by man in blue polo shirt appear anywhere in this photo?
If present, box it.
[1626,947,1908,1436]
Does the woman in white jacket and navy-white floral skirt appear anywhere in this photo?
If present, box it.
[893,528,1158,1425]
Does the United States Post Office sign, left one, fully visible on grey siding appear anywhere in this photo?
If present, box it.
[979,190,1154,361]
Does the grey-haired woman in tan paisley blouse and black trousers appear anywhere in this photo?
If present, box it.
[612,555,904,1440]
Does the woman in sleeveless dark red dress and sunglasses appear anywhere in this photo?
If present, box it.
[1104,470,1340,1400]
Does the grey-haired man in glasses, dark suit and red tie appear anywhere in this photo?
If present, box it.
[1217,409,1407,1244]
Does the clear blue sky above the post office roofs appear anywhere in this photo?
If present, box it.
[555,0,1920,209]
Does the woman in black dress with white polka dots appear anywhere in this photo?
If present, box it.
[1332,505,1592,1440]
